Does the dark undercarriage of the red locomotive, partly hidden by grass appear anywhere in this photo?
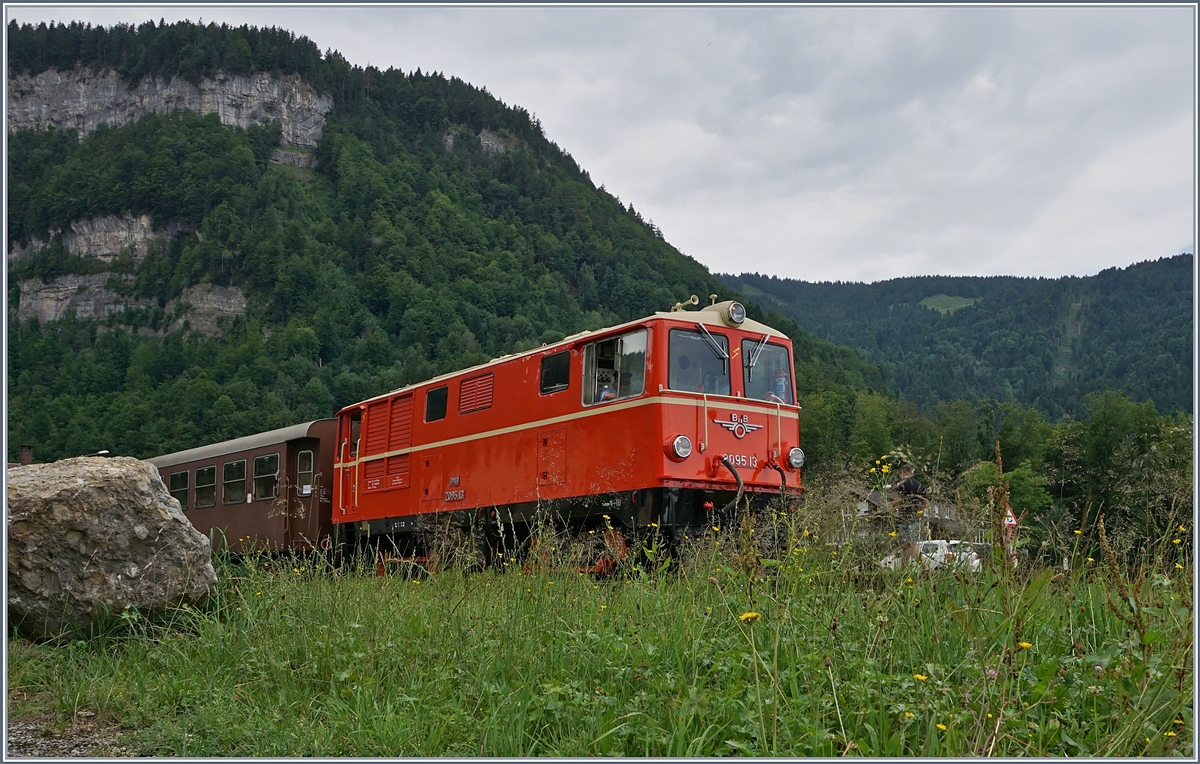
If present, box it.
[340,488,779,573]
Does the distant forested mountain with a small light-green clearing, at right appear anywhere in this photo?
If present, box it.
[720,254,1193,419]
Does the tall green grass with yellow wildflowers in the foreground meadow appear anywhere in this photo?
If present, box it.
[8,489,1194,757]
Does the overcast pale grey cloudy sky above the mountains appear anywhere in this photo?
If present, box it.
[6,5,1196,281]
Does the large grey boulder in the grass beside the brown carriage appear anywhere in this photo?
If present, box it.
[7,457,216,638]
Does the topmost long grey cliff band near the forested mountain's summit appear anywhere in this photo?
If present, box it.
[8,70,334,148]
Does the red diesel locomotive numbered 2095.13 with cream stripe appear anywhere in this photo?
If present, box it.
[332,296,804,561]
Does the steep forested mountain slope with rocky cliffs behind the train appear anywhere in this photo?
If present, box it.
[7,23,882,461]
